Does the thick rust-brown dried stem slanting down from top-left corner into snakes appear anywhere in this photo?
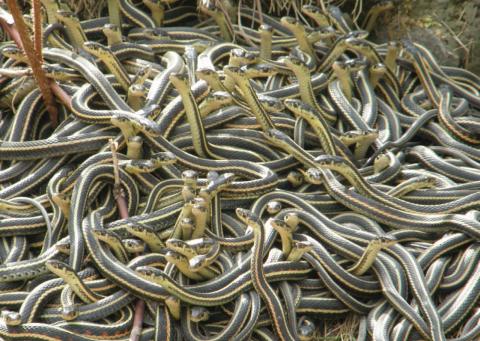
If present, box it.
[6,0,58,127]
